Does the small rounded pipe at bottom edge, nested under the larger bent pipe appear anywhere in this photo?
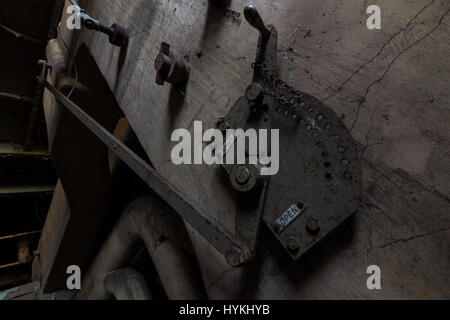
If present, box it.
[105,268,152,300]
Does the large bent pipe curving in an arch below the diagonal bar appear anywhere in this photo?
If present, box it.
[76,196,206,300]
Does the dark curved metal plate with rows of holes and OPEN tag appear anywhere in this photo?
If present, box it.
[226,87,362,259]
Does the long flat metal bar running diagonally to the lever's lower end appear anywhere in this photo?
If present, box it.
[40,78,243,255]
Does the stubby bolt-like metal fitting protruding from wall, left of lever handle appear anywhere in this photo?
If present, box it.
[155,42,187,86]
